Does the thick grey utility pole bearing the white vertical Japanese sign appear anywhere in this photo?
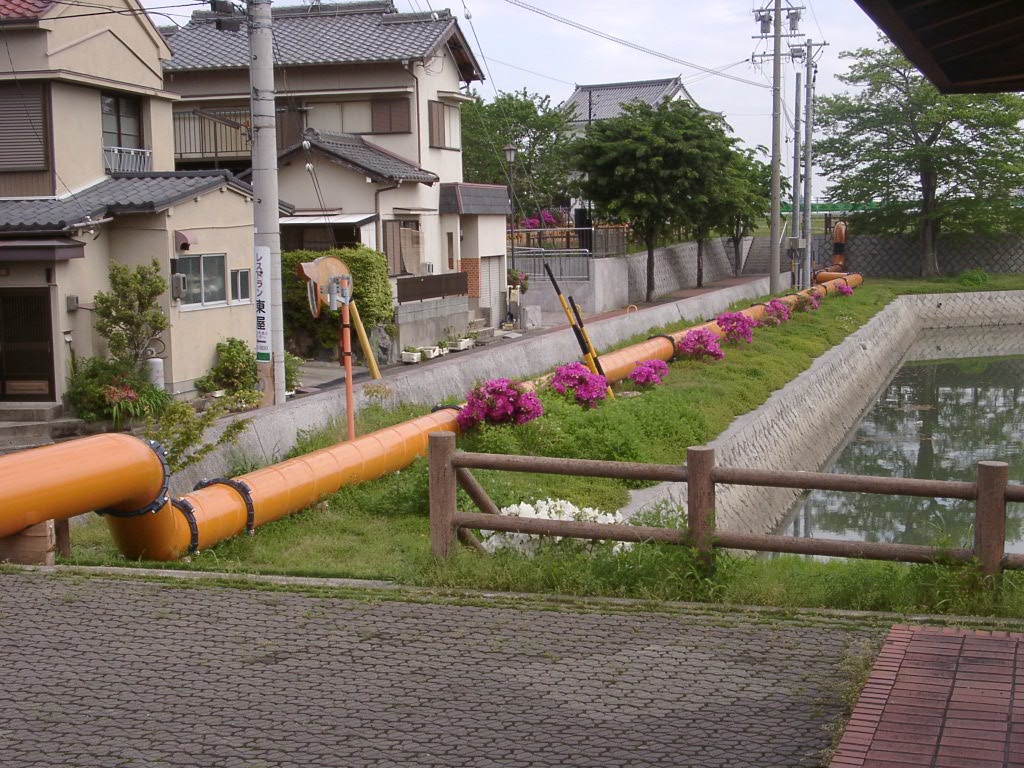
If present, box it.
[248,0,286,404]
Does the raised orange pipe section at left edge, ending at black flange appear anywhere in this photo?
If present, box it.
[0,433,168,537]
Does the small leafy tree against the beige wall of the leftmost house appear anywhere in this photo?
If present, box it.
[95,259,170,366]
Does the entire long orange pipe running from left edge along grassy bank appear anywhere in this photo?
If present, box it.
[0,273,862,560]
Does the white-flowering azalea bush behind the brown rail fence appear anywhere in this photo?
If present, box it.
[480,499,633,557]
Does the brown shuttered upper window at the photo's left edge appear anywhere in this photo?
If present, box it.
[0,83,50,171]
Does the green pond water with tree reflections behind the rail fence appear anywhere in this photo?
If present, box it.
[776,357,1024,552]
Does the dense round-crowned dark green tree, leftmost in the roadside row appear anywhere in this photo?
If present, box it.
[574,100,732,301]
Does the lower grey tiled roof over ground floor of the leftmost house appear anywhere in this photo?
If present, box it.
[0,171,251,232]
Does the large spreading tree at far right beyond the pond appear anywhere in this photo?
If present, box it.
[816,43,1024,276]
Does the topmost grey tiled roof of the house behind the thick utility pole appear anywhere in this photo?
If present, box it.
[163,0,482,81]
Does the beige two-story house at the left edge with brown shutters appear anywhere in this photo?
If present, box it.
[0,0,255,406]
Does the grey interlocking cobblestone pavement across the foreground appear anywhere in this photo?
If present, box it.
[0,571,886,768]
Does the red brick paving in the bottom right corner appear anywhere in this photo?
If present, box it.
[831,626,1024,768]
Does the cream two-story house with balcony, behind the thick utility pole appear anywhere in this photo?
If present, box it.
[163,0,509,345]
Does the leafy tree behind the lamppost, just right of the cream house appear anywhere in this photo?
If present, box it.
[462,89,572,219]
